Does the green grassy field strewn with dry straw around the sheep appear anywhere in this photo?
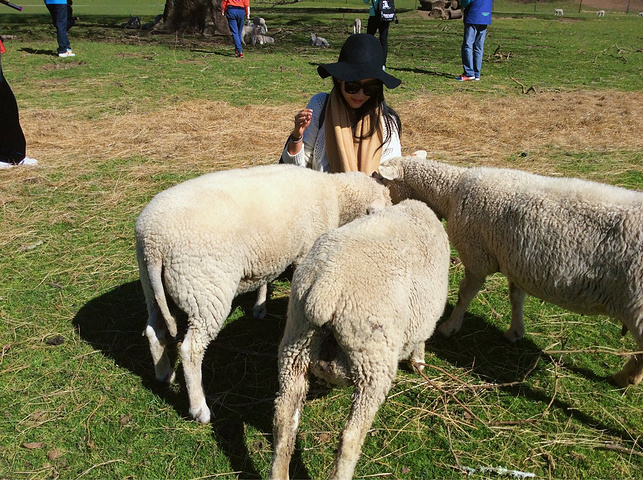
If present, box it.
[0,0,643,479]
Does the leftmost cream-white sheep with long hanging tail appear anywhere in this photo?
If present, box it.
[136,165,390,423]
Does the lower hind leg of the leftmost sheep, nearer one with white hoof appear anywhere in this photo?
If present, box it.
[181,326,218,423]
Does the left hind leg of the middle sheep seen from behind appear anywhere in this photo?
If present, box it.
[270,327,312,480]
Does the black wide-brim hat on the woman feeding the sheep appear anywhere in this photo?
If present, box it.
[317,33,402,88]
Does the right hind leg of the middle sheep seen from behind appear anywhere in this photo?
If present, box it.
[329,372,397,480]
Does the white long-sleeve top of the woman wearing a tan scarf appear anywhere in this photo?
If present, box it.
[281,93,402,172]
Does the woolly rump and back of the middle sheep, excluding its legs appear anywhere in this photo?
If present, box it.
[291,201,449,349]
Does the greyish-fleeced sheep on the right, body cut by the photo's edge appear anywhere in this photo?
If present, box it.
[379,156,643,386]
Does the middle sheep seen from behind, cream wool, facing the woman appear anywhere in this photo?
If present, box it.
[270,200,450,480]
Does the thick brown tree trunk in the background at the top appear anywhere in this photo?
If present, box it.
[155,0,230,35]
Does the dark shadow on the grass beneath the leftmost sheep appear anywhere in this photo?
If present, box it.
[73,281,308,478]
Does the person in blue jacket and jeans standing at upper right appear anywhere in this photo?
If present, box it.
[455,0,493,82]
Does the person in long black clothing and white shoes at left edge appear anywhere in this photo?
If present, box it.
[0,40,38,168]
